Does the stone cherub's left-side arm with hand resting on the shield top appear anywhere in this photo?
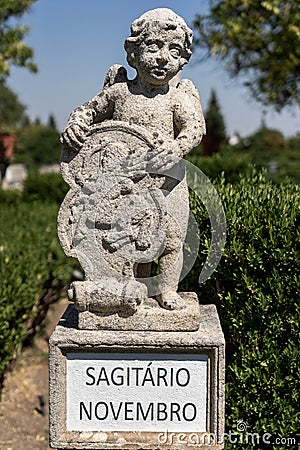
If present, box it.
[61,88,114,151]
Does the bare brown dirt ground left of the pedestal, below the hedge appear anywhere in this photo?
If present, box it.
[0,300,67,450]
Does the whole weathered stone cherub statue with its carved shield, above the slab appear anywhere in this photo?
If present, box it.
[58,8,205,314]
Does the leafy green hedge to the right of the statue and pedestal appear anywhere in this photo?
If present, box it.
[182,170,300,450]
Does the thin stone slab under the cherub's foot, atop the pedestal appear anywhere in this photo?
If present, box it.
[78,292,200,331]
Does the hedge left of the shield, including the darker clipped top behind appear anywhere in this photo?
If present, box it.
[0,171,71,384]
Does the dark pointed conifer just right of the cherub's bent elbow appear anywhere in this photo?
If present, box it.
[202,90,226,156]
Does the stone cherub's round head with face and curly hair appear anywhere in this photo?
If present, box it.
[125,11,192,86]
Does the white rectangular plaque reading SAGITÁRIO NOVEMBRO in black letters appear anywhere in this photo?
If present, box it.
[67,353,208,432]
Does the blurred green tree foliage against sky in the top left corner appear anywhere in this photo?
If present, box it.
[0,0,37,79]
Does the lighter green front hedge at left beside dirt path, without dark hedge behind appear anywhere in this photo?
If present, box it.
[0,200,74,380]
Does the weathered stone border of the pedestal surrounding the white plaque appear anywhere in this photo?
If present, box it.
[50,305,225,450]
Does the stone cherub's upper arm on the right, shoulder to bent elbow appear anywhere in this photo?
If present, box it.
[174,80,206,156]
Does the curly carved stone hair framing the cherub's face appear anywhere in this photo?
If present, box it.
[124,8,193,67]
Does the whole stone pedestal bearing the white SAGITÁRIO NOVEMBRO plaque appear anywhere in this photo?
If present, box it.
[50,305,225,450]
